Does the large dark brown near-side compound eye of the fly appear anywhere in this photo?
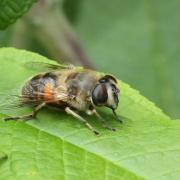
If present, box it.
[92,84,108,106]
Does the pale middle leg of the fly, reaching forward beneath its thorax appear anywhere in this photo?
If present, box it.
[65,107,99,135]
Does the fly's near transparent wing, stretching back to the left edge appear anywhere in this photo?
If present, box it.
[0,81,69,111]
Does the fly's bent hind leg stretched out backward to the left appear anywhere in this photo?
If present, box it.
[4,103,46,121]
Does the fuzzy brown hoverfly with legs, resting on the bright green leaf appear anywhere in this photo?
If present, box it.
[6,67,119,134]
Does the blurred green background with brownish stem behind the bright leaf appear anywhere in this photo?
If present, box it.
[0,0,180,119]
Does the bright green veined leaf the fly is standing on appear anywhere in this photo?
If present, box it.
[0,48,180,180]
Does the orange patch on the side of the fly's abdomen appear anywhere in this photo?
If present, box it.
[43,83,54,101]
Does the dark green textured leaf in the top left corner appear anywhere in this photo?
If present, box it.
[0,0,37,29]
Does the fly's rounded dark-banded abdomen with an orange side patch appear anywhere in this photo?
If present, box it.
[22,72,57,102]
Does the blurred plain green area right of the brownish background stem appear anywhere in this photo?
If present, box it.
[69,0,180,118]
